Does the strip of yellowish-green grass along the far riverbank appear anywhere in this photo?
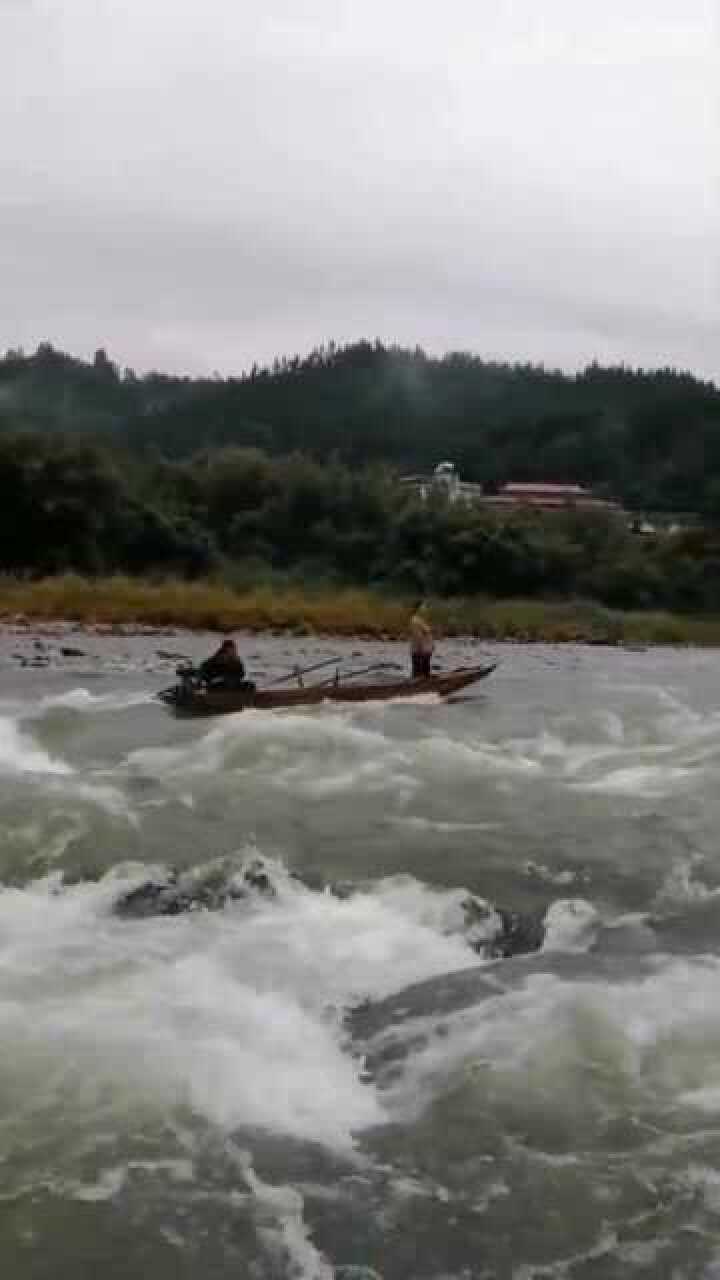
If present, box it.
[0,575,720,646]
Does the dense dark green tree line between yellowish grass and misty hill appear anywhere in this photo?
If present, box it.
[0,431,720,612]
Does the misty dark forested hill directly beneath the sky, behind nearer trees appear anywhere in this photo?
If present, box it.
[0,342,720,515]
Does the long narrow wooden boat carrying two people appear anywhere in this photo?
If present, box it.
[156,662,497,716]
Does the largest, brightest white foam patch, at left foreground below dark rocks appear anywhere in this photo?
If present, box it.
[0,868,486,1149]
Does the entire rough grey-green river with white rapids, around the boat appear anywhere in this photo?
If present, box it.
[0,632,720,1280]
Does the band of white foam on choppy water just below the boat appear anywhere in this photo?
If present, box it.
[120,680,720,800]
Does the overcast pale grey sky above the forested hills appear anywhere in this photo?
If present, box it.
[0,0,720,379]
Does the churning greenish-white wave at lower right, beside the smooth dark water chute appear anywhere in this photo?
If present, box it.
[364,957,720,1136]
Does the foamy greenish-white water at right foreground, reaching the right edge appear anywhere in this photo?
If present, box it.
[384,957,720,1124]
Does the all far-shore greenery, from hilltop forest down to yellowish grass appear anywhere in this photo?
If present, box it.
[0,343,720,636]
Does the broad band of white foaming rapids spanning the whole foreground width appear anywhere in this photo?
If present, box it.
[7,850,707,1153]
